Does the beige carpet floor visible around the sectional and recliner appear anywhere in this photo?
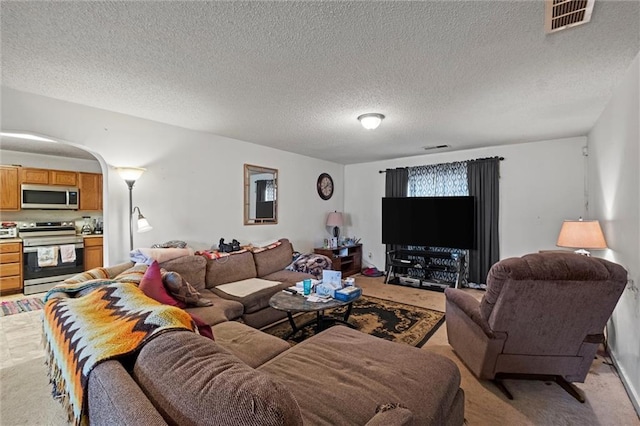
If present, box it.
[0,276,640,426]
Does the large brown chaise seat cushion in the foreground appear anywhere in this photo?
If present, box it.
[258,326,460,425]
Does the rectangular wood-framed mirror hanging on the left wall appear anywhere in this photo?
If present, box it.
[244,164,278,225]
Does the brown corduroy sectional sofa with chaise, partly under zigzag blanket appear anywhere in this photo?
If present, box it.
[66,240,464,426]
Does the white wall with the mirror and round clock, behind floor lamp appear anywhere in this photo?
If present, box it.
[2,87,344,264]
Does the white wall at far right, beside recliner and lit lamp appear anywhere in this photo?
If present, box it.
[588,55,640,413]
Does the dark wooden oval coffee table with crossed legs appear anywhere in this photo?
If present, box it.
[269,291,359,340]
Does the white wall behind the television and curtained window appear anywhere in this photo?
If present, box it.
[344,137,586,270]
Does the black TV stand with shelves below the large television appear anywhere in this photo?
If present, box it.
[384,249,465,291]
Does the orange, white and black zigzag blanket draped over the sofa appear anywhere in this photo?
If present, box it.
[43,280,195,425]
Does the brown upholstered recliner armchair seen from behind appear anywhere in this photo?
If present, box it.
[445,252,627,402]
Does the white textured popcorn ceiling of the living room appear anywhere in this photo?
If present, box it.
[0,0,640,164]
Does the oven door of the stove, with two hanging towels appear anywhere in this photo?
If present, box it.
[23,242,84,287]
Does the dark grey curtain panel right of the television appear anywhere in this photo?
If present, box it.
[467,157,500,284]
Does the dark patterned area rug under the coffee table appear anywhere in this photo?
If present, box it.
[262,296,444,348]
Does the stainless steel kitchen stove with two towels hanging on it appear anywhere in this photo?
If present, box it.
[18,221,84,295]
